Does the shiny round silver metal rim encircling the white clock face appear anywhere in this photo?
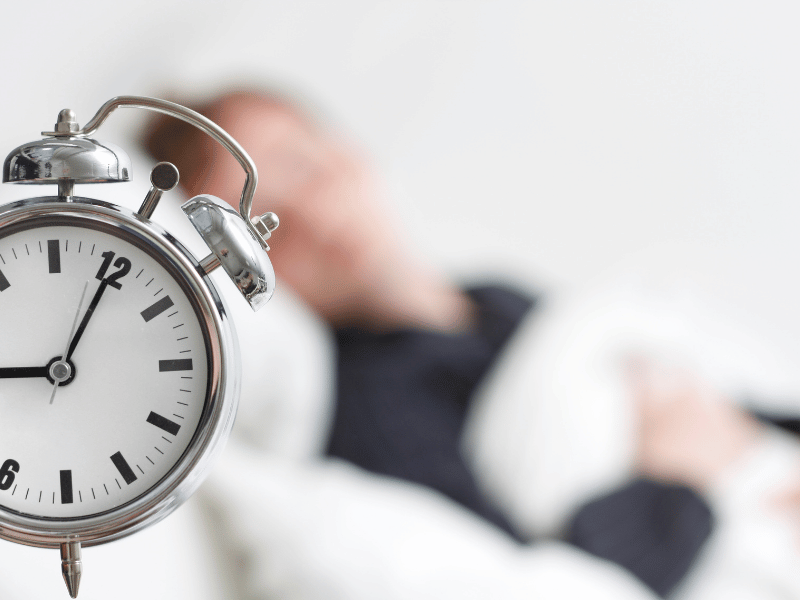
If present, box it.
[0,197,241,548]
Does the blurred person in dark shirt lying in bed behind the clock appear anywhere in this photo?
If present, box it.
[145,90,800,596]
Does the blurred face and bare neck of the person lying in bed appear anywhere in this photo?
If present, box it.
[182,94,474,331]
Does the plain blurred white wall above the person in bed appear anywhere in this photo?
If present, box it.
[0,0,800,368]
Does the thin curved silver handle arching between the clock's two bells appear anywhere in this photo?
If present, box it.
[42,96,267,249]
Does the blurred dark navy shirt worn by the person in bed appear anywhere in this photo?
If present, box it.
[328,287,711,595]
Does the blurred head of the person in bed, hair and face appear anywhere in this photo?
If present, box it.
[145,92,400,322]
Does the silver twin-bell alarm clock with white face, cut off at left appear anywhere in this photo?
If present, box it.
[0,96,278,598]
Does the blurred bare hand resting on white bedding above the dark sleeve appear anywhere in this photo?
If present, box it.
[629,359,762,491]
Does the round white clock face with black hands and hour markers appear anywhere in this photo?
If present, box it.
[0,218,210,519]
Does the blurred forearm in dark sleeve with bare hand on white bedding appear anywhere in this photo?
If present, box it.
[567,360,761,597]
